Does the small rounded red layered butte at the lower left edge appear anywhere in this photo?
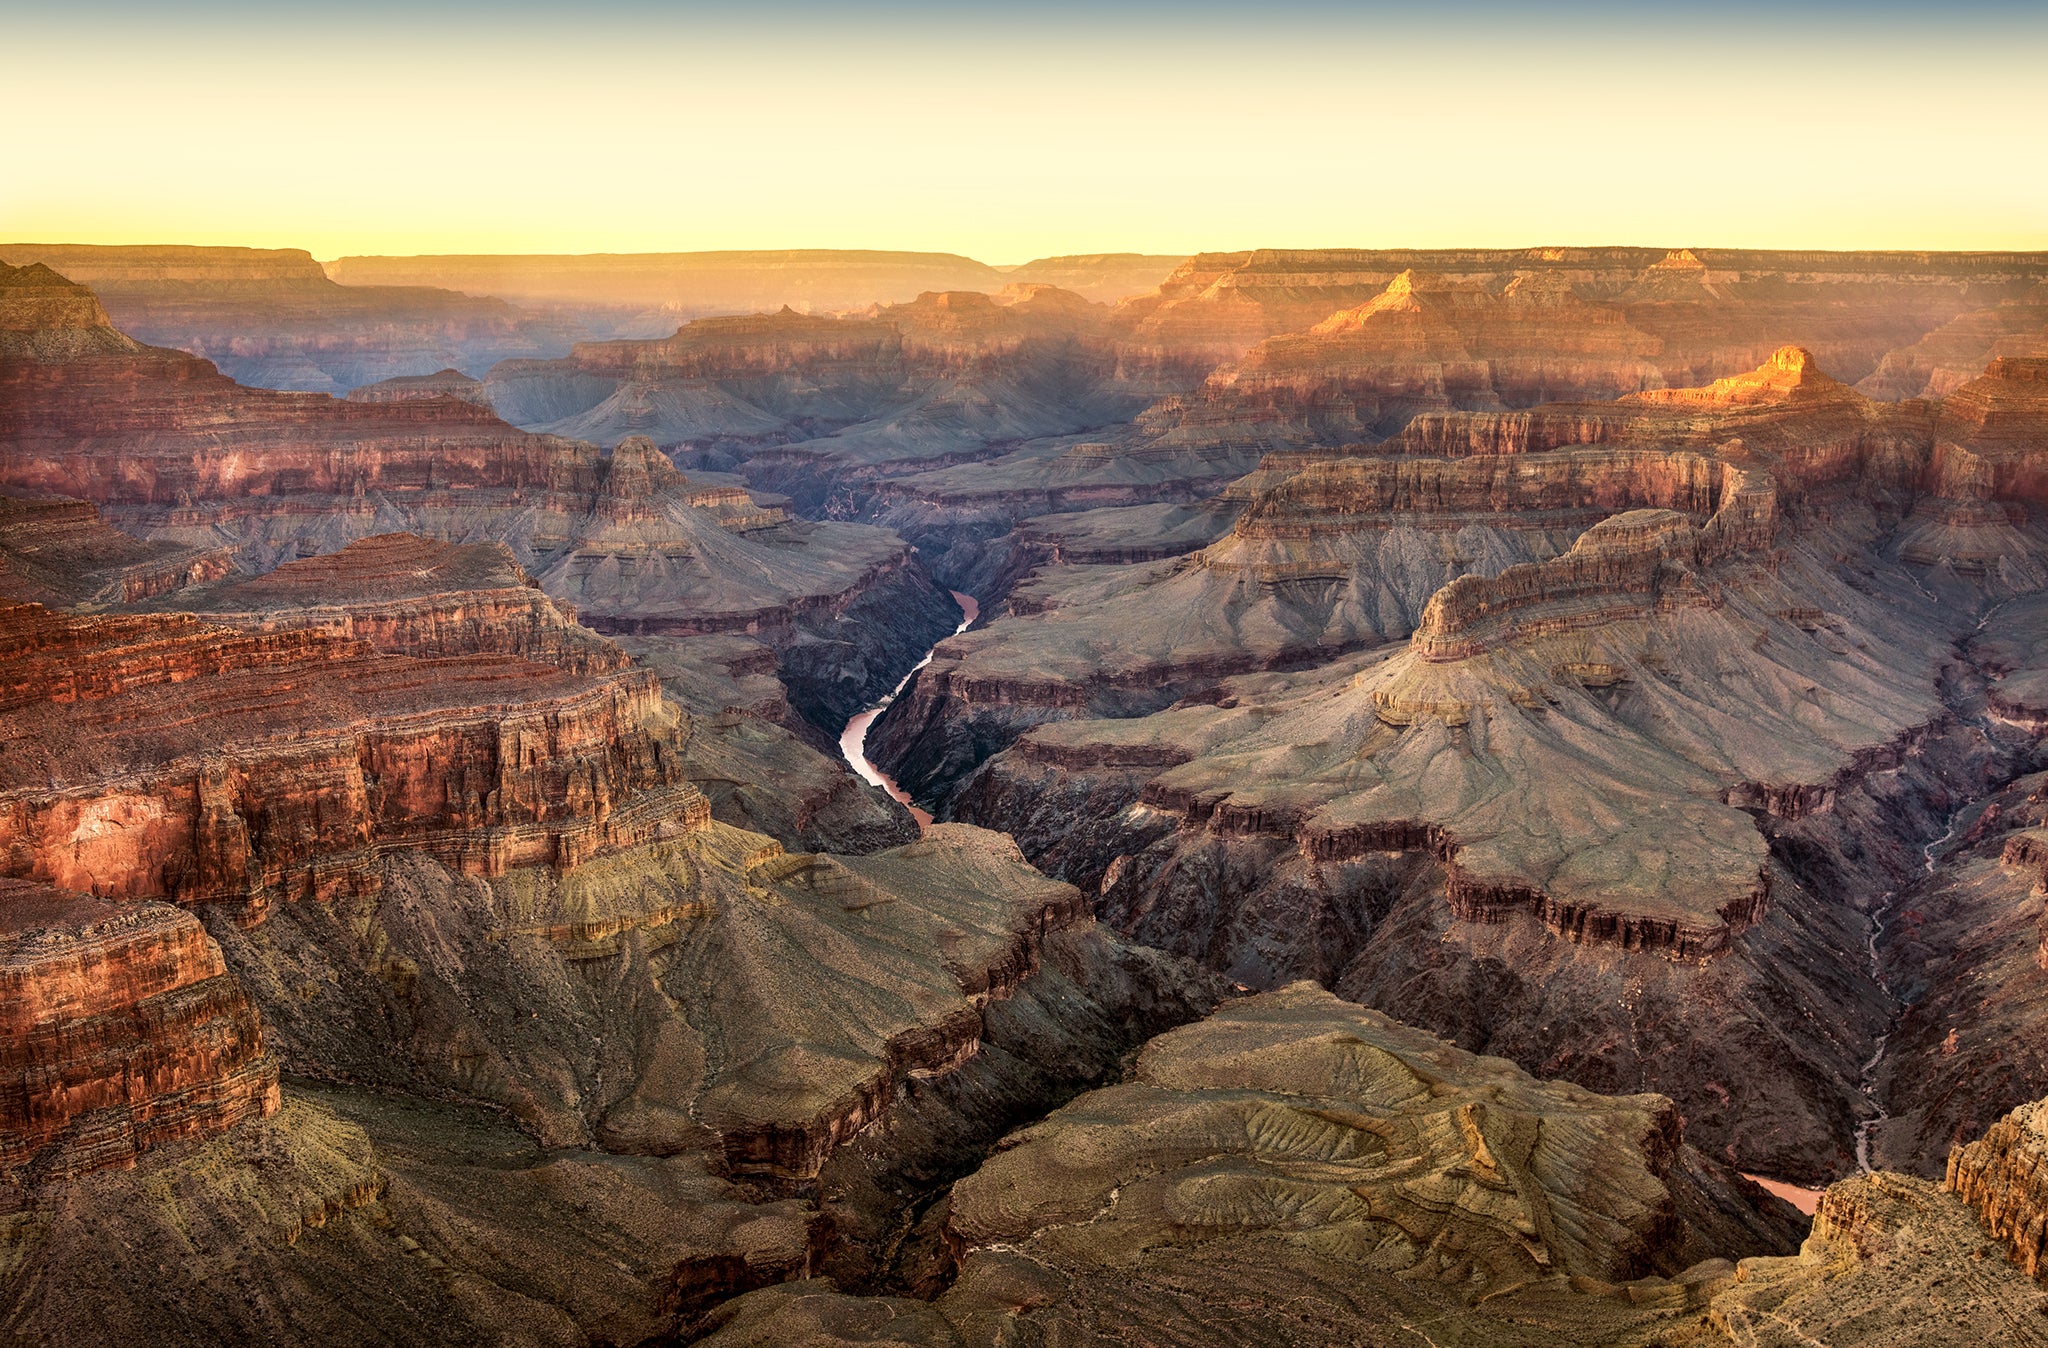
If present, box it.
[0,879,279,1207]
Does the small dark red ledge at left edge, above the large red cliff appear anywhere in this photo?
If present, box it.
[0,496,233,606]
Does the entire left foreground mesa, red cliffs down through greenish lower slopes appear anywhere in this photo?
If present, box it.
[0,506,1217,1342]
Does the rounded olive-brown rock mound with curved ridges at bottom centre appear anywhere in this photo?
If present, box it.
[709,985,1796,1344]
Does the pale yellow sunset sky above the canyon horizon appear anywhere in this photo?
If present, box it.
[0,0,2048,262]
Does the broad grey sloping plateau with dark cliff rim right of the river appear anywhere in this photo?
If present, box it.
[954,492,1962,1176]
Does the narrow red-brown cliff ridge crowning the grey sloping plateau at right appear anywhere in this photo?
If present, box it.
[1409,510,1718,662]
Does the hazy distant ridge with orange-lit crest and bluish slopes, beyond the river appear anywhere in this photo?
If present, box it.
[489,285,1139,485]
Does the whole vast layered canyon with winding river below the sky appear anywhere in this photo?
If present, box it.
[0,246,2048,1348]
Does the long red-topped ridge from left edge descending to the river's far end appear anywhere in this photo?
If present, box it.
[0,270,958,727]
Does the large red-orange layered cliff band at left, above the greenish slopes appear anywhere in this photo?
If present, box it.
[0,604,709,912]
